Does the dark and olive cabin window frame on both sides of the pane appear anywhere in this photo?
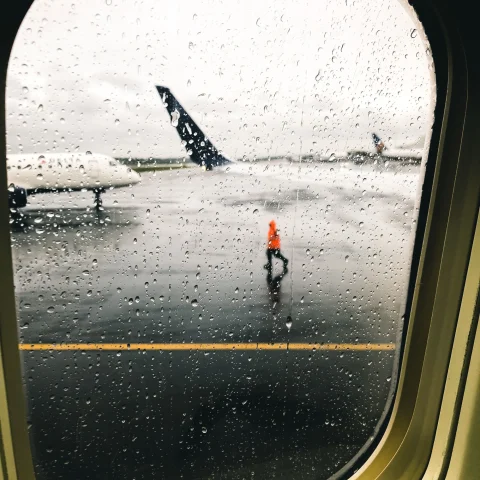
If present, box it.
[0,0,480,480]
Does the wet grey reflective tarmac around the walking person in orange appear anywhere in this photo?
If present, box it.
[12,162,420,479]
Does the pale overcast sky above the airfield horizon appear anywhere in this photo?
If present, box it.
[7,0,434,158]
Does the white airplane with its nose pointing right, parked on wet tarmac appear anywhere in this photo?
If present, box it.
[7,152,140,210]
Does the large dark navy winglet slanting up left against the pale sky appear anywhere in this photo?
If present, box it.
[157,85,230,170]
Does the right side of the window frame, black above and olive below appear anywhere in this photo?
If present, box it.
[349,1,480,480]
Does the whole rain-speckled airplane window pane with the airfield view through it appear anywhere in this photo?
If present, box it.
[7,0,435,479]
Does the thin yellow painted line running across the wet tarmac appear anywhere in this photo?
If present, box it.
[19,343,395,351]
